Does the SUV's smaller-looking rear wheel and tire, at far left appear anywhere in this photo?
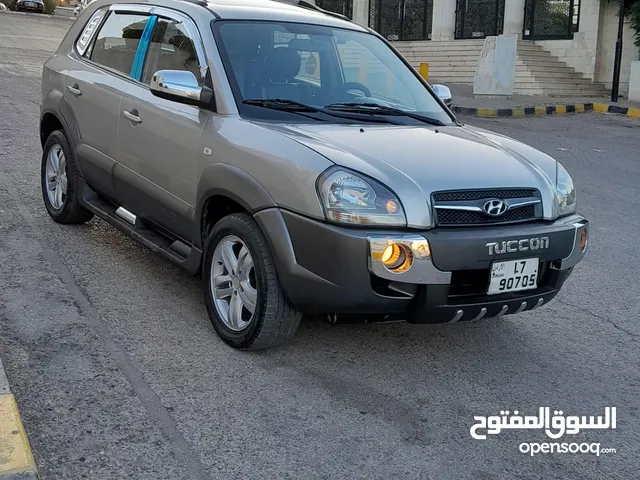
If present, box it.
[40,130,93,224]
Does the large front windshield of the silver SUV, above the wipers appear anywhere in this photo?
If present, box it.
[214,21,452,124]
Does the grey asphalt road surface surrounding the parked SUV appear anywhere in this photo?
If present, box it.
[0,15,640,480]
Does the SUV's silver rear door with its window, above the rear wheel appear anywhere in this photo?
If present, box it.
[64,5,150,198]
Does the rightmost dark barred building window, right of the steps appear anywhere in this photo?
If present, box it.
[522,0,580,40]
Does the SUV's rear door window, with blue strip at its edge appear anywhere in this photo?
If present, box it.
[90,12,149,75]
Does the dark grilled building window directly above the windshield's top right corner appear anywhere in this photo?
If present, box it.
[369,0,433,41]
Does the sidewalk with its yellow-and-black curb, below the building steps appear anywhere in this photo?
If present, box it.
[447,84,640,118]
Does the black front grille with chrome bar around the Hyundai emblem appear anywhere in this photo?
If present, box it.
[433,188,542,227]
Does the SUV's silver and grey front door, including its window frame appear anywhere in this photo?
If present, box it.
[114,8,210,240]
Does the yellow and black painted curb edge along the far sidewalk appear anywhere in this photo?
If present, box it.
[453,103,640,118]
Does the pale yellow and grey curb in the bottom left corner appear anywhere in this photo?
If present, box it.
[0,359,38,480]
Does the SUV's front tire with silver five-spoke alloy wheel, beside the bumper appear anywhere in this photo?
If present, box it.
[202,213,302,350]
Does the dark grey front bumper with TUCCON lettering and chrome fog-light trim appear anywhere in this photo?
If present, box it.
[255,209,588,323]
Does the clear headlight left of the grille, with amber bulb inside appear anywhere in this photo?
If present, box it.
[318,168,407,227]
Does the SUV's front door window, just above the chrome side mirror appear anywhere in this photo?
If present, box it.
[141,18,204,86]
